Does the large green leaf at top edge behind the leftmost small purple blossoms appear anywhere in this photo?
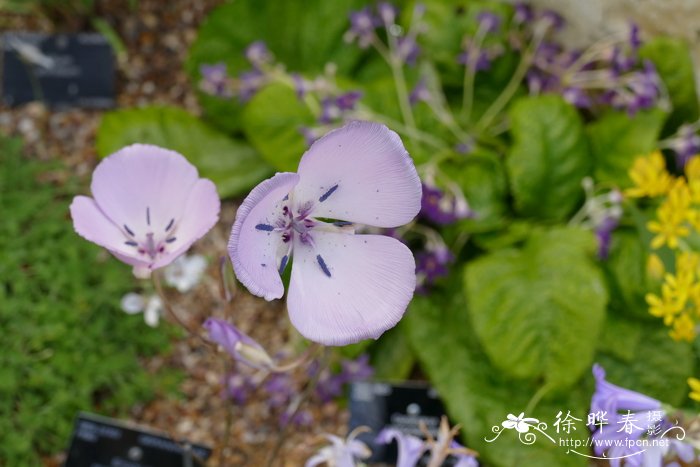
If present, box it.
[186,0,365,131]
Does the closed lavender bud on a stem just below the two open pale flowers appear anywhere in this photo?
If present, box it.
[204,318,274,368]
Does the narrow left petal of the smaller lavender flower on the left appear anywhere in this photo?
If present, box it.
[70,196,144,266]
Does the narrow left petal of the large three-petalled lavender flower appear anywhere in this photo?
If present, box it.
[228,172,299,300]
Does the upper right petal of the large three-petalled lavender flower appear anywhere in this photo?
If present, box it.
[294,121,422,227]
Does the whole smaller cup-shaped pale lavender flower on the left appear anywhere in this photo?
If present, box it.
[70,144,220,277]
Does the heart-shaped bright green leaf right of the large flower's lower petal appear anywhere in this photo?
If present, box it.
[465,228,607,387]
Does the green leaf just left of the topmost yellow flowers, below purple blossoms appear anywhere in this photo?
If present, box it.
[587,109,666,187]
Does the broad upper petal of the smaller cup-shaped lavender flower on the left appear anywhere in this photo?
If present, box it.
[90,144,198,239]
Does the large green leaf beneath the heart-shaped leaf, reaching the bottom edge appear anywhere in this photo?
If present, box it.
[404,277,591,467]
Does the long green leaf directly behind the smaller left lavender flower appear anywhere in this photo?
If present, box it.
[97,107,272,198]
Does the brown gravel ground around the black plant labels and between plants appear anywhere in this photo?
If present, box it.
[0,0,348,466]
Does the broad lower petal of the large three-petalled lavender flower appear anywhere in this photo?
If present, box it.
[287,232,416,345]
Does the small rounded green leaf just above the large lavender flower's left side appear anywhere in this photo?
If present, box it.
[243,84,314,172]
